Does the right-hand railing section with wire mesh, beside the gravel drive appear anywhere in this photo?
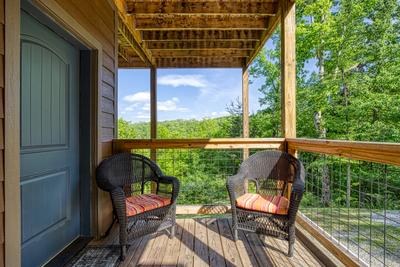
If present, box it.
[288,139,400,266]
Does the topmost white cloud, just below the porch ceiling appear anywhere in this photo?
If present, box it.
[158,74,209,88]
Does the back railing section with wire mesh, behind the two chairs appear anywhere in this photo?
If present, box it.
[114,138,284,205]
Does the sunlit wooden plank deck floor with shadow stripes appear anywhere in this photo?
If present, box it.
[93,218,323,267]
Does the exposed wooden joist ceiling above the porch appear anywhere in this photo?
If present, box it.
[115,0,279,68]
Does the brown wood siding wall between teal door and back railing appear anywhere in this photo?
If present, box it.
[51,0,117,236]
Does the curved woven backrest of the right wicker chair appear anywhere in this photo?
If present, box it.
[240,151,300,194]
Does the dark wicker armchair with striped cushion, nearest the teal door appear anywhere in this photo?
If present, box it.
[96,153,179,260]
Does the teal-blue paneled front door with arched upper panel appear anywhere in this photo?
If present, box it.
[21,11,80,266]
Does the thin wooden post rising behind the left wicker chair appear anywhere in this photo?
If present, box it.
[150,67,157,194]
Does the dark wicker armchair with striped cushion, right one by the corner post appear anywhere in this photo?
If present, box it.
[227,151,304,257]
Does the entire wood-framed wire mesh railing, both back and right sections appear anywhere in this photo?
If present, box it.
[113,138,400,266]
